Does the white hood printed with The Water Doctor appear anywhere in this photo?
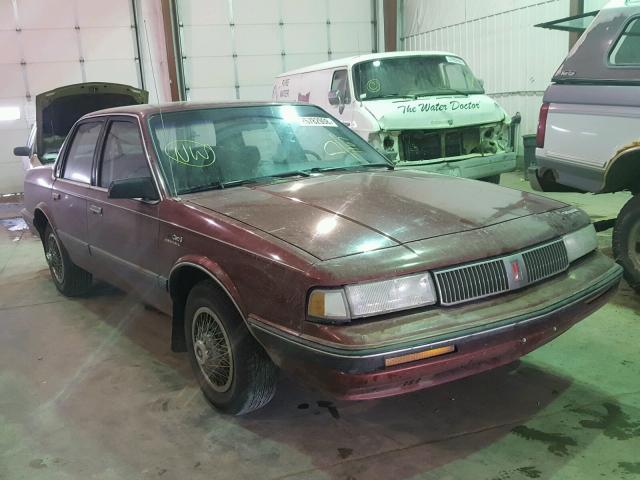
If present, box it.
[363,95,506,130]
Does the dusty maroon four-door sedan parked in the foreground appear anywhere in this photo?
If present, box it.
[23,103,621,414]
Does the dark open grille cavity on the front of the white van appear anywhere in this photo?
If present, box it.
[400,127,480,162]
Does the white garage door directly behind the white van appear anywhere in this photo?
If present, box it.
[177,0,376,100]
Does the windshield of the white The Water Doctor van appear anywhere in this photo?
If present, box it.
[353,55,484,100]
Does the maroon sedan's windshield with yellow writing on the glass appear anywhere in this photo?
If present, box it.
[149,105,391,195]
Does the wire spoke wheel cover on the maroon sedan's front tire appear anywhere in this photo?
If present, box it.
[191,307,233,393]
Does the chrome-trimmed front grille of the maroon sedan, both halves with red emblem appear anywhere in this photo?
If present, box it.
[433,240,569,305]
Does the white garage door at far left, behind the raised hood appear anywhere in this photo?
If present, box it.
[0,0,141,193]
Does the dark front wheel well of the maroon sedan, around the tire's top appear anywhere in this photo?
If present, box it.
[169,265,241,352]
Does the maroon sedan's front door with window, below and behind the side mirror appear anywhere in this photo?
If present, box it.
[87,117,164,305]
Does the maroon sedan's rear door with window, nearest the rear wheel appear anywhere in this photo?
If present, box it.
[51,119,104,269]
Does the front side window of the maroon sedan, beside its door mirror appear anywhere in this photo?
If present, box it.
[99,121,151,188]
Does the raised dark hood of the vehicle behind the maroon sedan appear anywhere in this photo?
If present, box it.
[36,82,149,163]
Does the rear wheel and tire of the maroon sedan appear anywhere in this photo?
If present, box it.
[43,225,92,297]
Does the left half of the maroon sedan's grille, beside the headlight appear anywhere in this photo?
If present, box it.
[435,260,509,305]
